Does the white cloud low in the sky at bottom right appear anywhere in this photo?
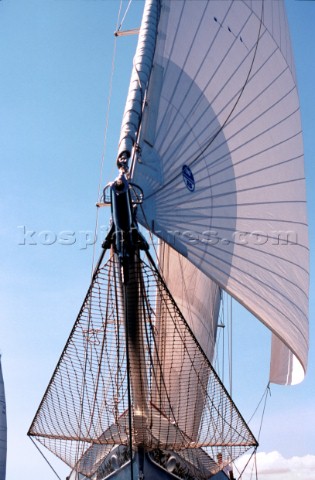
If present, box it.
[235,452,315,480]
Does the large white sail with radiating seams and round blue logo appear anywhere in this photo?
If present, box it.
[133,0,309,383]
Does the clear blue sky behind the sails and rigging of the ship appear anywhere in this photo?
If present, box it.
[0,0,315,480]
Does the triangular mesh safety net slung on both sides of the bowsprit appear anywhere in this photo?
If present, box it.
[29,249,256,478]
